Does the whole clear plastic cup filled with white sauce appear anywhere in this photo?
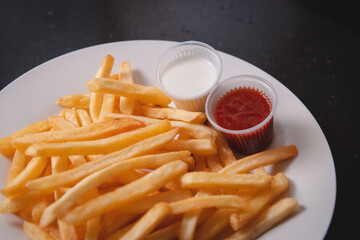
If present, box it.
[155,41,222,112]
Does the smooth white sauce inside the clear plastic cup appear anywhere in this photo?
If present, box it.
[160,57,216,99]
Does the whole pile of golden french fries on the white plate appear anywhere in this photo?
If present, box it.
[0,55,298,240]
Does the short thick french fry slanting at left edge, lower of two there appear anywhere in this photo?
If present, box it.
[1,157,49,198]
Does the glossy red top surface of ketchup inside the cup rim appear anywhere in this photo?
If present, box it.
[214,88,271,130]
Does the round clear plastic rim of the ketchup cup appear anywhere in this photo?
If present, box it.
[205,74,278,135]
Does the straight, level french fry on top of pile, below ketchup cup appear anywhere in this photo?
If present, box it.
[181,172,272,189]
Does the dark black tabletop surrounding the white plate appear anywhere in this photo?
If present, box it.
[0,0,360,239]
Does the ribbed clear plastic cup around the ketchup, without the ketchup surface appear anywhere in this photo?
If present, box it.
[205,75,277,154]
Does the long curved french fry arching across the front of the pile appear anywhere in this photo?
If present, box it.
[40,151,190,227]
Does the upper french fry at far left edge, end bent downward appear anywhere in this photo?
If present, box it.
[0,120,50,157]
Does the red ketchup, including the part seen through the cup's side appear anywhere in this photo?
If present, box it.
[214,88,273,154]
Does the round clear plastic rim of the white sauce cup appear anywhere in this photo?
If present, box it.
[155,40,223,101]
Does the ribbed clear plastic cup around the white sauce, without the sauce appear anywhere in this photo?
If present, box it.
[155,41,222,112]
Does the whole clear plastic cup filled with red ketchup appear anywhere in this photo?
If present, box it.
[206,75,277,154]
